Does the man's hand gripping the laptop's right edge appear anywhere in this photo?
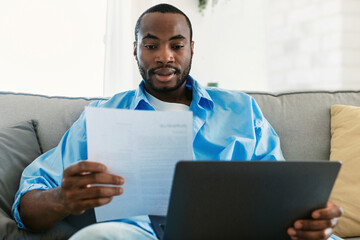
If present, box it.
[287,202,343,240]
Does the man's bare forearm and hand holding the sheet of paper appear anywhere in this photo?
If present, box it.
[19,161,124,230]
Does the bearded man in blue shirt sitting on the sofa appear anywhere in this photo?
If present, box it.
[13,4,342,239]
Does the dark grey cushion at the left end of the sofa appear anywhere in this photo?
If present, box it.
[0,121,75,239]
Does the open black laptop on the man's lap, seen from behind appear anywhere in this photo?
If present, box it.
[149,161,341,240]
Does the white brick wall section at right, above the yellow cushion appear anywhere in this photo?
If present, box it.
[266,0,360,91]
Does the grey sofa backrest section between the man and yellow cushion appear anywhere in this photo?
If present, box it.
[250,91,360,161]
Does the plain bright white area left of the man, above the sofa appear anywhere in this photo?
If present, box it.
[0,0,106,96]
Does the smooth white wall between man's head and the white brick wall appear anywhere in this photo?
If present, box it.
[192,0,268,91]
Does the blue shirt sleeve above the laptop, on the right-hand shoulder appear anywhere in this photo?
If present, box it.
[252,96,284,160]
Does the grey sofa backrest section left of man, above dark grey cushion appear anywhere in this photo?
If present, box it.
[0,92,99,152]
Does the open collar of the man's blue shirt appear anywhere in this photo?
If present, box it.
[130,75,214,110]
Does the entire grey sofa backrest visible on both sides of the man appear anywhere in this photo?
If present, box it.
[0,91,360,160]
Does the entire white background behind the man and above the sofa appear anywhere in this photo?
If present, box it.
[0,0,360,96]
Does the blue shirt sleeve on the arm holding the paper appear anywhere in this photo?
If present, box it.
[12,109,87,229]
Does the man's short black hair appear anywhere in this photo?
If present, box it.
[135,3,192,42]
